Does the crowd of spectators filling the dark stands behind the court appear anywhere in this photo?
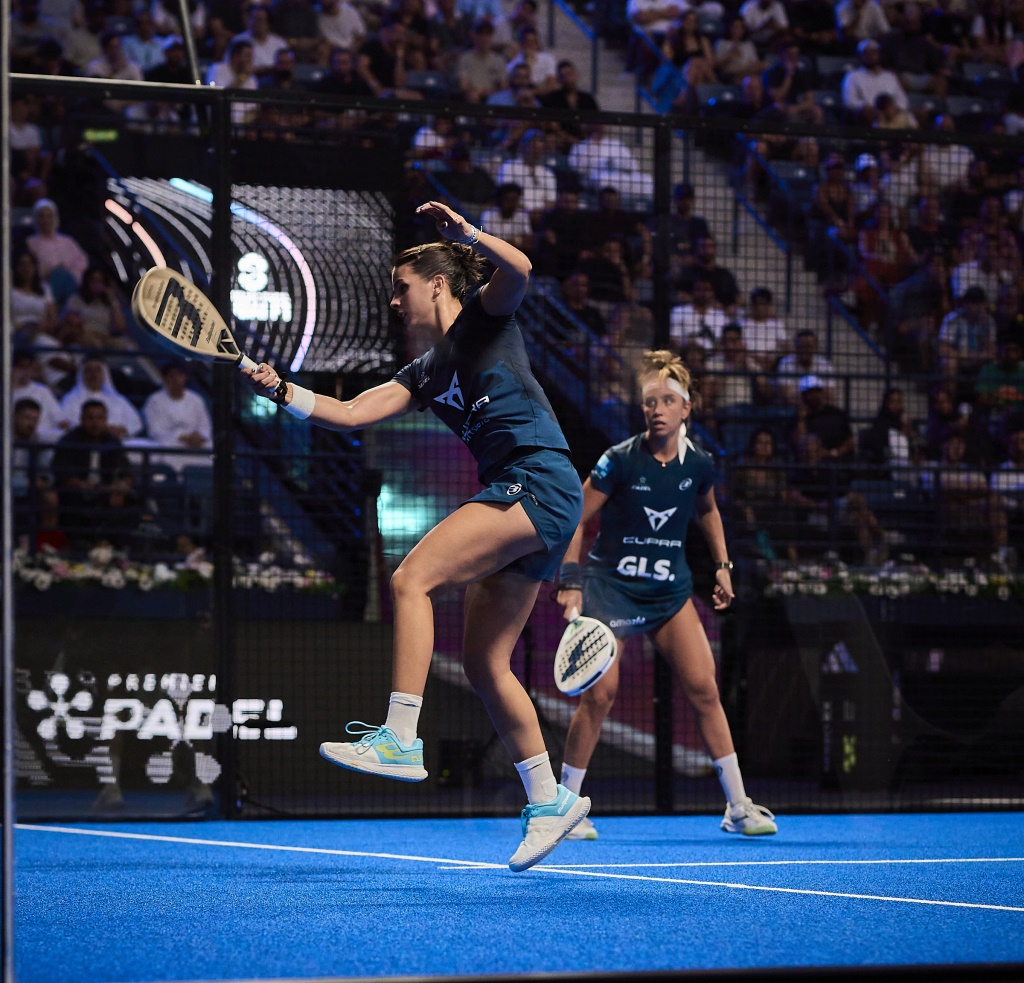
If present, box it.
[10,0,1024,569]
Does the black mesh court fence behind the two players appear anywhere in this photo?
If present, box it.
[12,76,1024,818]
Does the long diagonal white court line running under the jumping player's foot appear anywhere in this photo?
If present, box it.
[14,823,1024,913]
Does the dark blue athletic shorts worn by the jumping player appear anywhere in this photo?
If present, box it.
[463,450,583,581]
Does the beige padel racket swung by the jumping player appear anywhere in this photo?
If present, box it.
[131,267,256,371]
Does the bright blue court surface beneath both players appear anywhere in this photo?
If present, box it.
[15,813,1024,983]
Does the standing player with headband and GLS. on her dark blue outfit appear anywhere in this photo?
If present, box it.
[556,351,777,840]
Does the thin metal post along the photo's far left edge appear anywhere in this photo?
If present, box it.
[0,0,14,966]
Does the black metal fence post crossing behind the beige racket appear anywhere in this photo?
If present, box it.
[210,94,240,819]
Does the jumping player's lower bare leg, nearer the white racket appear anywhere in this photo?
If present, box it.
[463,571,546,761]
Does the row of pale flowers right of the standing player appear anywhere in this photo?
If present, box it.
[765,560,1024,601]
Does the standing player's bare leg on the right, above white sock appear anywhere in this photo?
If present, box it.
[653,600,735,761]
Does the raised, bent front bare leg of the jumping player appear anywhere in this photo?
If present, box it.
[391,502,544,696]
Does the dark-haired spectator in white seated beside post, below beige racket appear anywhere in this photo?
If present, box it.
[142,358,213,472]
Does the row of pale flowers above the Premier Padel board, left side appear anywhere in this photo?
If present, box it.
[11,546,339,594]
